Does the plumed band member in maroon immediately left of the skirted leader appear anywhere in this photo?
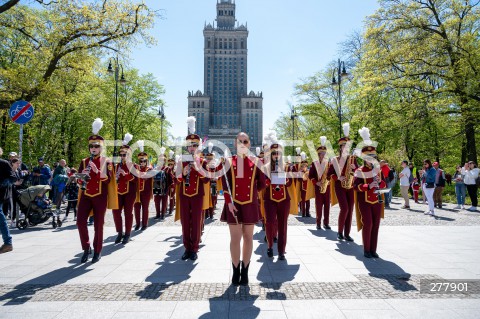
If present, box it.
[176,116,208,260]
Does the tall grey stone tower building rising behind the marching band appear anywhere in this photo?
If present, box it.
[188,0,263,147]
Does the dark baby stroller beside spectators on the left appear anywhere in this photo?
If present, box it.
[17,185,62,229]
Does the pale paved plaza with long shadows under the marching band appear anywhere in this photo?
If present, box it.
[0,199,480,319]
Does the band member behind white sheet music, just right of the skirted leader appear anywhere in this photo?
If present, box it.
[264,143,296,260]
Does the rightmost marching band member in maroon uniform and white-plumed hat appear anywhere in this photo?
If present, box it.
[353,127,386,258]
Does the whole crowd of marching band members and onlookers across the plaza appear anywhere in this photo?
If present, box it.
[0,117,479,285]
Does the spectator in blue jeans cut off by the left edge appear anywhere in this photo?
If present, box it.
[0,148,16,254]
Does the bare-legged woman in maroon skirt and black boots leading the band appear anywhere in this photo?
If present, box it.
[221,132,265,285]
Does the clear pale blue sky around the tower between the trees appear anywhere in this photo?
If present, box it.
[128,0,379,140]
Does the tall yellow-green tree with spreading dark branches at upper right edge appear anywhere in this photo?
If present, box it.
[358,0,480,161]
